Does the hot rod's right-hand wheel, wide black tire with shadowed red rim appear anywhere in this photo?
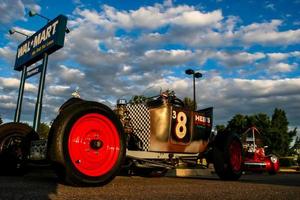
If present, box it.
[213,133,243,180]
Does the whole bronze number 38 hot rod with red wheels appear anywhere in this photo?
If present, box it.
[44,91,242,185]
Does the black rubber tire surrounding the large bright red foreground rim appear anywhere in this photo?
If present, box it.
[48,101,126,186]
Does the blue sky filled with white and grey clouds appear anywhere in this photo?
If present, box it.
[0,0,300,134]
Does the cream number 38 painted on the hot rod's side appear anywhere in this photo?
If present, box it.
[172,111,187,139]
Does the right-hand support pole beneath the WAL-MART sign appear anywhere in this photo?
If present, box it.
[33,53,48,132]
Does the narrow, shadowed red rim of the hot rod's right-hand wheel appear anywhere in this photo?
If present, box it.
[229,140,242,172]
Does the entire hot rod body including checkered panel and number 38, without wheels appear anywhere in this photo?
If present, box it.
[119,100,213,153]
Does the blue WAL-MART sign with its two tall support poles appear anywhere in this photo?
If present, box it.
[14,15,68,132]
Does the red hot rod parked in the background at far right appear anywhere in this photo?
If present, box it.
[242,127,279,174]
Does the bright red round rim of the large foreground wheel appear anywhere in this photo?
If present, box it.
[68,113,120,177]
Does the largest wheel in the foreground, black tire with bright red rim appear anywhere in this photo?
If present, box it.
[49,101,126,186]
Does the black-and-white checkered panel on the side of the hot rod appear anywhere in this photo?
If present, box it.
[127,104,150,151]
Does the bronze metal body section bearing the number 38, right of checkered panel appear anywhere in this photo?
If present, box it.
[149,104,211,153]
